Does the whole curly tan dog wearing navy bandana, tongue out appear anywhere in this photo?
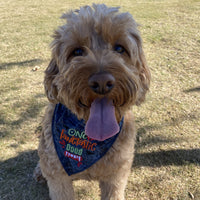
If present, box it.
[36,4,150,200]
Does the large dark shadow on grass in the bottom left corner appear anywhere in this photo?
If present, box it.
[0,149,48,200]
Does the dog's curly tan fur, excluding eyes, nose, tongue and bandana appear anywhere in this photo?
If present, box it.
[34,4,150,200]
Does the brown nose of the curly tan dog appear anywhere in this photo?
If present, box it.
[88,73,115,95]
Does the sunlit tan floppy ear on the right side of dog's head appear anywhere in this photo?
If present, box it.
[131,28,151,105]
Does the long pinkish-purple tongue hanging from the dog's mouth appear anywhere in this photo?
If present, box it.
[85,97,119,141]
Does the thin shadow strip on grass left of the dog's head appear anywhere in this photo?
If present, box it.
[0,59,42,70]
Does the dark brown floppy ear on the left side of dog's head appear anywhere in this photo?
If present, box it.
[44,59,59,103]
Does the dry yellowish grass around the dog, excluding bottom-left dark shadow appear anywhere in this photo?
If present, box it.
[0,0,200,200]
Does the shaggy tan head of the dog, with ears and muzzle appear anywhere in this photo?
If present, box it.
[44,4,150,140]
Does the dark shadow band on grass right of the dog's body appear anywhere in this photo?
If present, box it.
[133,149,200,167]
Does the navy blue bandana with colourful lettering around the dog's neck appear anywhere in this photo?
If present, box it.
[52,104,123,176]
